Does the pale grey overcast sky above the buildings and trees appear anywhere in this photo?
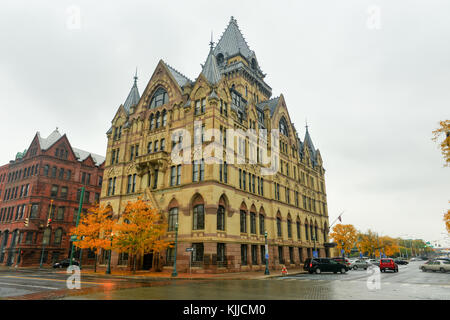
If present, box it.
[0,0,450,245]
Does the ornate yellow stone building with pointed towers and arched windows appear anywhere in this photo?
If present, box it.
[101,17,329,272]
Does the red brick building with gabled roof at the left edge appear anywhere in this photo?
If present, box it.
[0,129,105,266]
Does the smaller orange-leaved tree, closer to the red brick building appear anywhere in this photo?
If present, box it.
[70,204,115,272]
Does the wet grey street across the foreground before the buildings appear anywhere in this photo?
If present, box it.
[0,261,450,300]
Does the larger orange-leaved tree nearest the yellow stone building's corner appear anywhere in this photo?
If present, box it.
[114,198,171,271]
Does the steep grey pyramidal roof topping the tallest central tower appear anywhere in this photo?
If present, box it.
[214,17,254,60]
